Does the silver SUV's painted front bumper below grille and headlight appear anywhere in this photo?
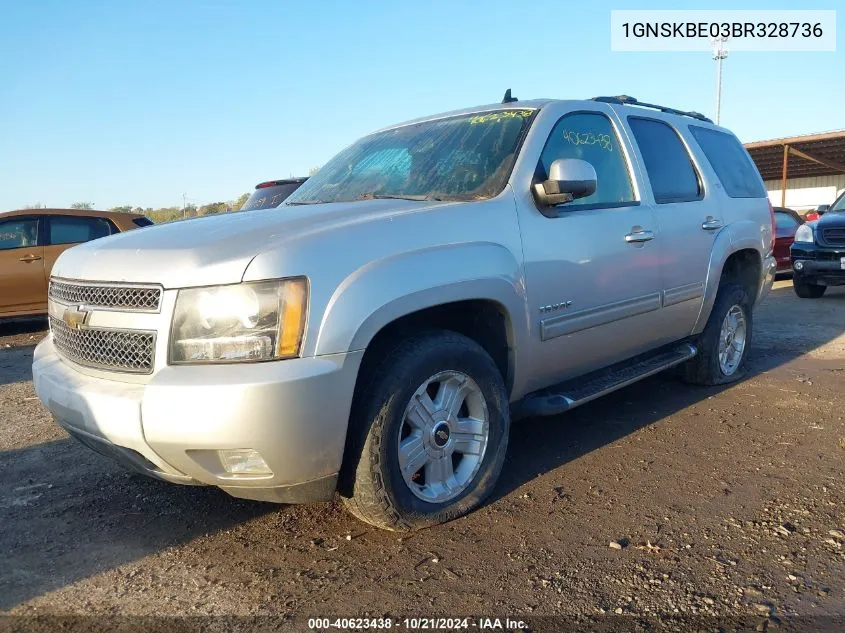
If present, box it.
[32,336,363,503]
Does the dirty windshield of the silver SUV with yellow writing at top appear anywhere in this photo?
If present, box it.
[285,109,534,204]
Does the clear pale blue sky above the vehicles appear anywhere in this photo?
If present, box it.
[0,0,845,210]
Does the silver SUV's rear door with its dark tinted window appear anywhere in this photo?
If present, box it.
[626,116,724,340]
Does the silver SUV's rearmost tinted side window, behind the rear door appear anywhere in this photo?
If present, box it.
[690,125,767,198]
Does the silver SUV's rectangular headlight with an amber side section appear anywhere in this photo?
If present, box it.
[170,278,308,364]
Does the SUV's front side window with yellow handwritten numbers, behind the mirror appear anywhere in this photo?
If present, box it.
[537,112,634,207]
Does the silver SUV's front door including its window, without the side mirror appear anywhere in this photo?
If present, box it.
[517,106,661,390]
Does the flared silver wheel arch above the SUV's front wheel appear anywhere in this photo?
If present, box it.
[315,242,528,355]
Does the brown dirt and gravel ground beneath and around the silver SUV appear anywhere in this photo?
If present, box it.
[0,281,845,625]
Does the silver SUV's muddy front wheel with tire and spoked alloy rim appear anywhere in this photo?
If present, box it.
[342,331,510,530]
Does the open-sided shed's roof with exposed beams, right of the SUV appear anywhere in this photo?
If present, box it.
[745,130,845,180]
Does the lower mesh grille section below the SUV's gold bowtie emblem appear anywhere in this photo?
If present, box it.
[50,316,156,374]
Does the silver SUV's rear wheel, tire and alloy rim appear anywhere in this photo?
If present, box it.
[683,282,754,385]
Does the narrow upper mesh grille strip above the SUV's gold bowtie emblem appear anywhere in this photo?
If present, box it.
[49,279,161,312]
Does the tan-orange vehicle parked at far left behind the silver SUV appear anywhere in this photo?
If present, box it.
[0,209,152,318]
